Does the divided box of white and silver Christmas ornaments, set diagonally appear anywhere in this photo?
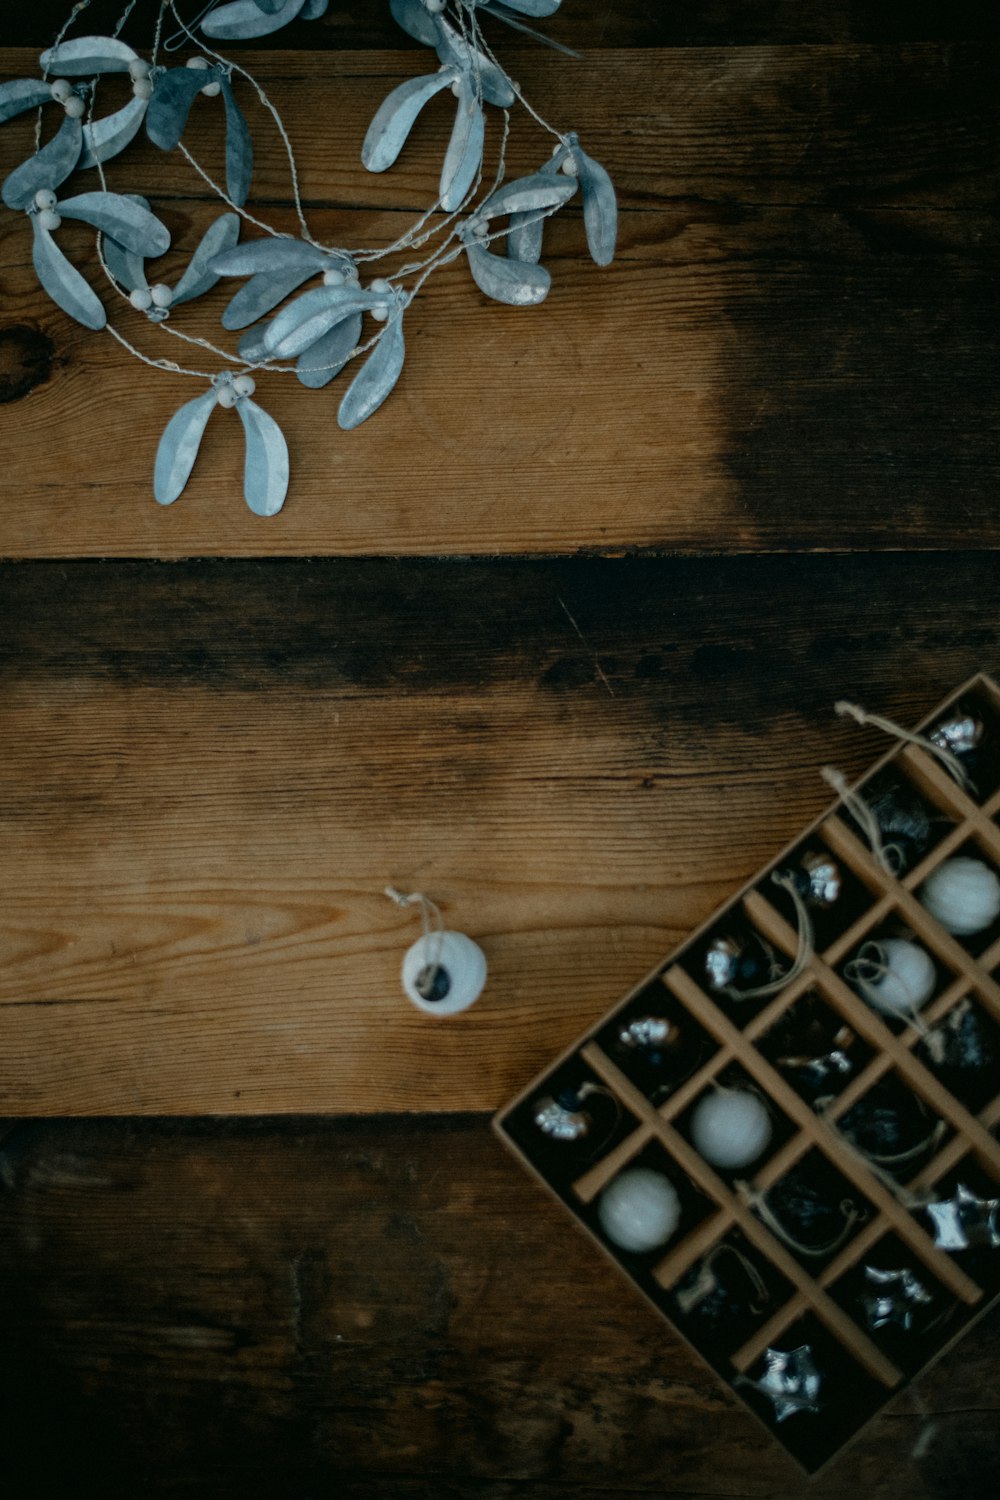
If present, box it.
[495,677,1000,1473]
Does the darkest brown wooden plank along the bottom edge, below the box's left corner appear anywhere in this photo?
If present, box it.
[0,1118,1000,1500]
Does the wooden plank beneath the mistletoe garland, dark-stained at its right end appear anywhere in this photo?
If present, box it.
[0,47,1000,557]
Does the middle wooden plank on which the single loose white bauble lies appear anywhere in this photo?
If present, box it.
[0,555,1000,1115]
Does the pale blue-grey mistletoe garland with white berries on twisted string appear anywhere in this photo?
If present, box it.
[0,0,618,516]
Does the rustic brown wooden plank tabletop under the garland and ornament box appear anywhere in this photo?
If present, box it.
[0,0,1000,1500]
